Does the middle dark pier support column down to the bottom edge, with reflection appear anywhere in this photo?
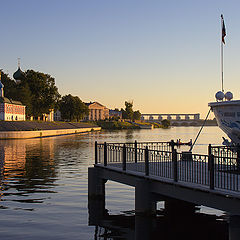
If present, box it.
[135,180,156,240]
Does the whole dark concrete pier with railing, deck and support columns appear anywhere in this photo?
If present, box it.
[89,142,240,240]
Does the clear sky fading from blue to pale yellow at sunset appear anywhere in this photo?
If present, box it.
[0,0,240,118]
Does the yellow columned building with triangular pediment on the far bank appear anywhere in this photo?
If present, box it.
[85,102,109,121]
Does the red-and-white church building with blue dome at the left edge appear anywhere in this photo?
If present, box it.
[0,71,25,121]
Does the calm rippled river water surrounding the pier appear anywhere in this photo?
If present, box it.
[0,127,230,240]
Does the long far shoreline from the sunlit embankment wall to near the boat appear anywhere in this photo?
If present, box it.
[0,120,217,140]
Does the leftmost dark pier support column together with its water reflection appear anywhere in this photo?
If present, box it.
[88,167,106,225]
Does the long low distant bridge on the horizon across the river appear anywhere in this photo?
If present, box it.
[141,113,200,122]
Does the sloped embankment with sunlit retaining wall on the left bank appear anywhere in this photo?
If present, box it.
[0,121,101,139]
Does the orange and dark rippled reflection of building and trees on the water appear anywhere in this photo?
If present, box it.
[0,139,56,210]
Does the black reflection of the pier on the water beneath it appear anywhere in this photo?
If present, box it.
[89,206,228,240]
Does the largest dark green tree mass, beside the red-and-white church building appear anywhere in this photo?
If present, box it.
[1,70,60,117]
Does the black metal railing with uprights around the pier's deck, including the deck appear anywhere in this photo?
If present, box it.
[95,141,240,192]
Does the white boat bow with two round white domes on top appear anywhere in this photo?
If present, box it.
[208,91,240,145]
